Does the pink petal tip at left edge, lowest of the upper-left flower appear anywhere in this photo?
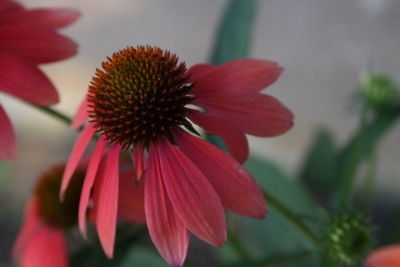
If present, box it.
[0,105,17,160]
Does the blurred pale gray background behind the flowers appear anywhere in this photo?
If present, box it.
[0,0,400,265]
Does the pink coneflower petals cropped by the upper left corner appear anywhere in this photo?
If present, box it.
[0,0,79,160]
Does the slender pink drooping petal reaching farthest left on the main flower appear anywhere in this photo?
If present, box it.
[60,124,96,200]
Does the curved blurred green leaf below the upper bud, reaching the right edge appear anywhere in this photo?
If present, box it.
[336,108,400,205]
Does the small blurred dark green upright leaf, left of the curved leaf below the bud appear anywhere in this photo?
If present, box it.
[300,129,337,201]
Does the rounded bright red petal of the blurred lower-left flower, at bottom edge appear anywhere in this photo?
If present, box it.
[21,224,68,267]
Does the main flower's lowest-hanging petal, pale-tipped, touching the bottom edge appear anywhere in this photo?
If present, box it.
[144,146,189,266]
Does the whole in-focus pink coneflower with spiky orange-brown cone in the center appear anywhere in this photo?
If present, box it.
[61,46,293,266]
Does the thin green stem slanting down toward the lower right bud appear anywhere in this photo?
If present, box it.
[262,190,319,244]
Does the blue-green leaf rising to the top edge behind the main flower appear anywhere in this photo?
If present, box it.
[210,0,257,64]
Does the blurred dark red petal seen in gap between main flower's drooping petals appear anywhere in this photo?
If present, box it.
[118,170,146,224]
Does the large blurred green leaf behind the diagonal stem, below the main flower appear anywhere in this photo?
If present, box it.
[217,157,323,266]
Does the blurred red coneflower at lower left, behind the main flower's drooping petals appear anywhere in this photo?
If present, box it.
[13,165,145,267]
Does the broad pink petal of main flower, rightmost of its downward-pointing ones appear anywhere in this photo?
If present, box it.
[175,131,267,219]
